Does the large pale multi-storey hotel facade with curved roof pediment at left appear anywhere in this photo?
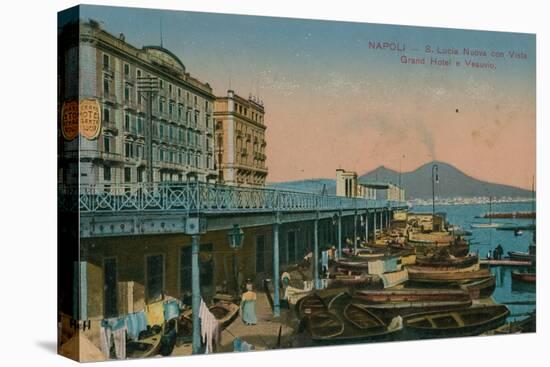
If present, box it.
[65,21,217,189]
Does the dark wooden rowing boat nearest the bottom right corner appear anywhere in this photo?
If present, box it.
[404,305,510,337]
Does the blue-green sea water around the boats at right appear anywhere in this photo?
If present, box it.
[411,202,536,321]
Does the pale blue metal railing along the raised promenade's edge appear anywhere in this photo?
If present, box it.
[59,182,405,214]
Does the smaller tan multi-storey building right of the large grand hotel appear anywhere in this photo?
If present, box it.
[214,90,268,187]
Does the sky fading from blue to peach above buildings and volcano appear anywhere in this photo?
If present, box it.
[72,6,536,189]
